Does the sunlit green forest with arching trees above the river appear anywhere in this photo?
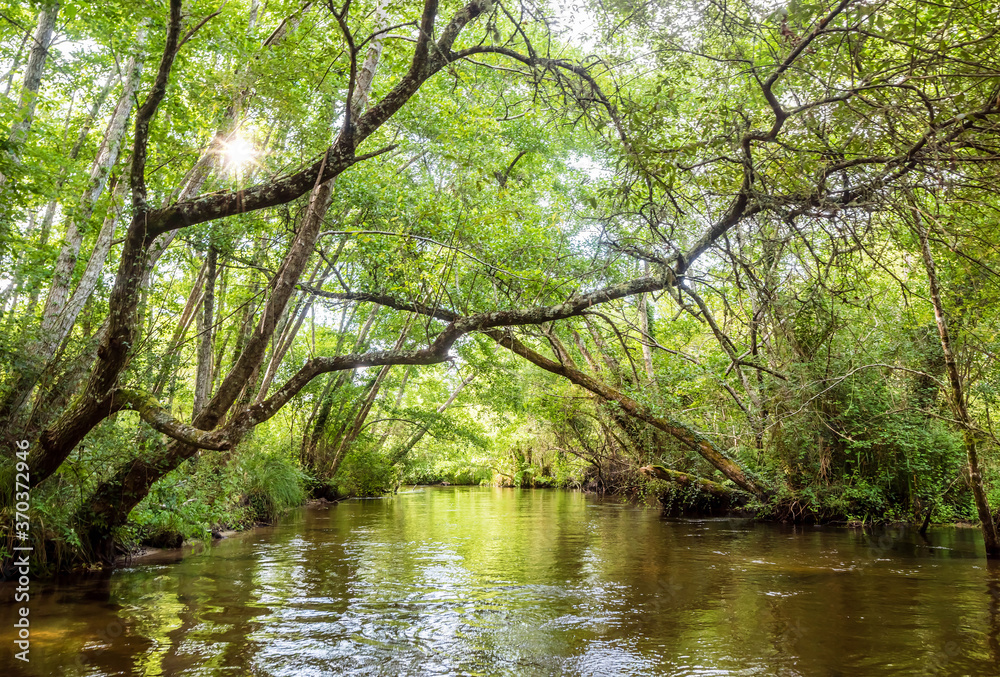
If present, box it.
[0,0,1000,561]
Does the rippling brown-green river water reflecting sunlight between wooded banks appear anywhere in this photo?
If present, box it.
[0,487,1000,677]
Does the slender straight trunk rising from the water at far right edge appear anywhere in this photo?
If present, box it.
[916,223,1000,559]
